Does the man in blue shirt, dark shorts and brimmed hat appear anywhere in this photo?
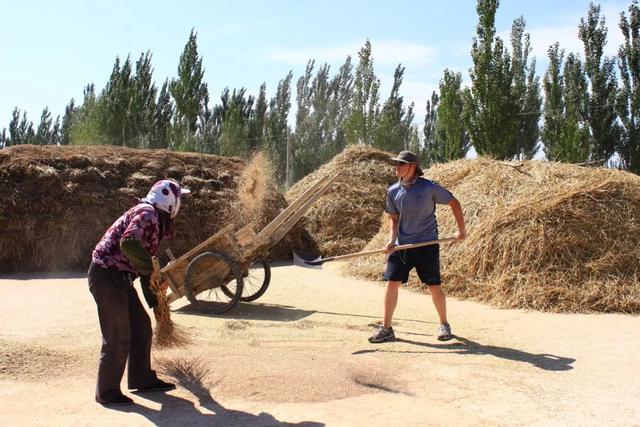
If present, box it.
[369,151,467,343]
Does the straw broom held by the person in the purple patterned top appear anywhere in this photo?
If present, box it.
[151,257,191,348]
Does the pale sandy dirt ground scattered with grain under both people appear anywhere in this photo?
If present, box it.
[0,264,640,426]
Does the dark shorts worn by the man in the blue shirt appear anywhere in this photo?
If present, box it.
[384,245,440,285]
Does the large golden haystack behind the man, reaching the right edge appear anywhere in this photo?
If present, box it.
[348,158,640,313]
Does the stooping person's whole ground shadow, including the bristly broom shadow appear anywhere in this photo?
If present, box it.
[112,359,324,427]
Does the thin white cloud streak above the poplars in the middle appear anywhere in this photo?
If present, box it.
[267,40,435,66]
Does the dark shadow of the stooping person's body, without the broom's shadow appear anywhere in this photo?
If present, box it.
[113,390,324,427]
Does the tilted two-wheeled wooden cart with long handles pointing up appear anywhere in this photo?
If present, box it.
[160,176,337,314]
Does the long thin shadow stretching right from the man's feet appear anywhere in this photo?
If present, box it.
[353,335,576,371]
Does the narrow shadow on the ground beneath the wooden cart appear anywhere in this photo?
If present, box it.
[175,302,317,322]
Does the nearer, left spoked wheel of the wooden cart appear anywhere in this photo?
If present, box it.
[184,252,243,314]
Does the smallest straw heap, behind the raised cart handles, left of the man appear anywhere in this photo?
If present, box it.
[285,145,396,256]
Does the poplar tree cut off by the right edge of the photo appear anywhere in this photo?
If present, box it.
[616,0,640,174]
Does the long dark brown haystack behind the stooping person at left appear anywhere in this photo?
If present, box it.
[0,145,312,273]
